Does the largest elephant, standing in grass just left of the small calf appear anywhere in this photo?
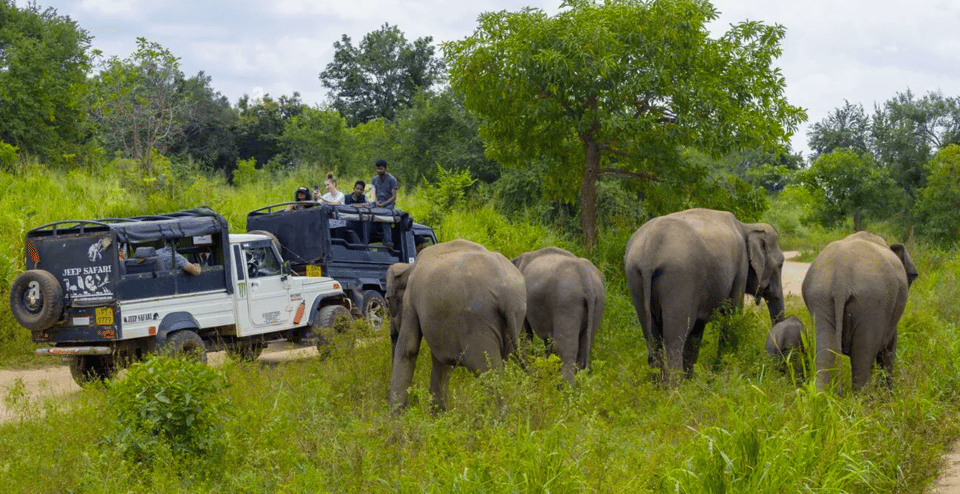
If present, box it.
[624,209,783,382]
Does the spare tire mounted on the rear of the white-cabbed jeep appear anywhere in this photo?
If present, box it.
[10,269,63,331]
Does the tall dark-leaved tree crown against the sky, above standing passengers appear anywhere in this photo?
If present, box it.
[320,24,444,126]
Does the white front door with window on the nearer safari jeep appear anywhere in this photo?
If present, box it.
[241,240,296,333]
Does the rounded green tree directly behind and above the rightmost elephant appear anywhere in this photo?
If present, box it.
[800,149,903,231]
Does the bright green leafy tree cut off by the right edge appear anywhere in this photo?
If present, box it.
[914,144,960,243]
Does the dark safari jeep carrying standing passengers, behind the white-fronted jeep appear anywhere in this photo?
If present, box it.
[247,202,437,328]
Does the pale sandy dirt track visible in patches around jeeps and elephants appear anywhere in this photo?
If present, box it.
[0,252,960,494]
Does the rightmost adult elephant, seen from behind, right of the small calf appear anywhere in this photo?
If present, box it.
[801,232,917,390]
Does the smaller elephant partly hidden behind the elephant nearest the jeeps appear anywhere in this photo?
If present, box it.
[513,247,607,386]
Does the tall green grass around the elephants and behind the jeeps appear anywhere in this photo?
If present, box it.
[0,164,960,493]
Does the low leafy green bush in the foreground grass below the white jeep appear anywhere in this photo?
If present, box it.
[108,356,227,460]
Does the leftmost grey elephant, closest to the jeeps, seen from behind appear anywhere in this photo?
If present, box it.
[387,240,527,410]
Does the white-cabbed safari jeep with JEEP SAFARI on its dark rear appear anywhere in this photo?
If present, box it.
[10,208,351,382]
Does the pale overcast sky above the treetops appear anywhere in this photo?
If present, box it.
[33,0,960,156]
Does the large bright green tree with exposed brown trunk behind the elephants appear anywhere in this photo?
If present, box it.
[444,0,805,248]
